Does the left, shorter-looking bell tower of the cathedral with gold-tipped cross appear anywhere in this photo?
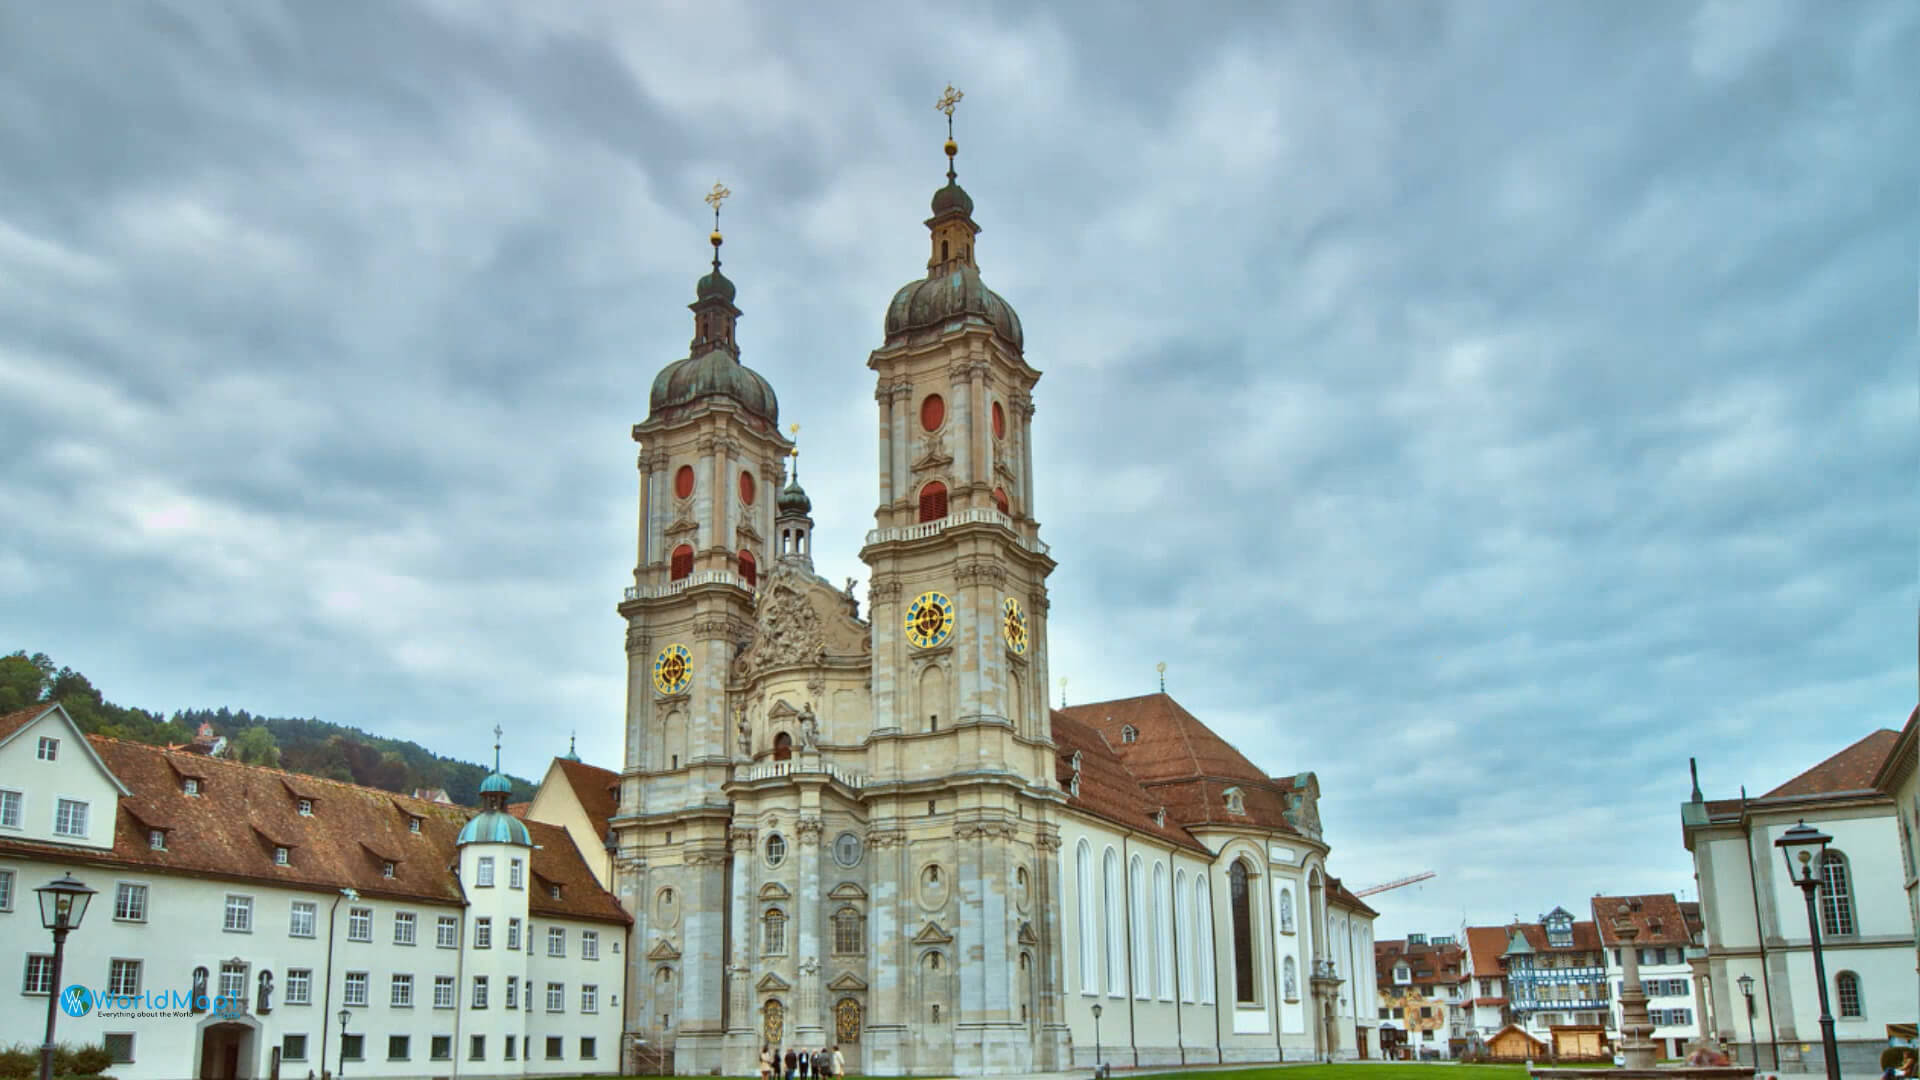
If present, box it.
[612,184,791,1072]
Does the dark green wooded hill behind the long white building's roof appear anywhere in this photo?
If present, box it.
[0,650,534,805]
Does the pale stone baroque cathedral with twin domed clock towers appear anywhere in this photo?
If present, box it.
[607,94,1379,1076]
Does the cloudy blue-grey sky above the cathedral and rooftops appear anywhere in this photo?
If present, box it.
[0,0,1920,936]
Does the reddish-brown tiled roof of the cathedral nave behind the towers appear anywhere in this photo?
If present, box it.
[1054,694,1306,834]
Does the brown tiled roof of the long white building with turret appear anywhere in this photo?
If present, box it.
[0,736,628,922]
